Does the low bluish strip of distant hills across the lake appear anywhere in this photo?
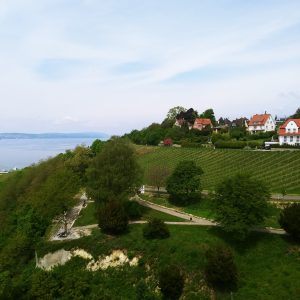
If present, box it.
[0,132,109,139]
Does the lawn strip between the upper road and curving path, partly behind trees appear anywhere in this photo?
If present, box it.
[141,194,281,228]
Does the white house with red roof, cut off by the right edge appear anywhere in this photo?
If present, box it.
[278,119,300,146]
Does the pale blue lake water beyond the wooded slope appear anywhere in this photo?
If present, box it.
[0,138,95,170]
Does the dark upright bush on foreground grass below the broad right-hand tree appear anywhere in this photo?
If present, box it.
[204,246,238,290]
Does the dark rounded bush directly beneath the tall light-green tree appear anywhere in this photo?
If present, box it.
[98,201,128,234]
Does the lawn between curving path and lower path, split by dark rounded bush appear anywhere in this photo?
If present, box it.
[74,202,185,227]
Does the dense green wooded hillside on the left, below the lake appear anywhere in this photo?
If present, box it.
[0,147,88,299]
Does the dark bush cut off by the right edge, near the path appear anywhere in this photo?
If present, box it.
[278,203,300,241]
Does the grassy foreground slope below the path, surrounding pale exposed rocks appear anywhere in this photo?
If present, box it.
[37,224,300,300]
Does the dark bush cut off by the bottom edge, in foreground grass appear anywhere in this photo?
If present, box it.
[159,265,184,300]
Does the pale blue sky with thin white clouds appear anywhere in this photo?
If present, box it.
[0,0,300,134]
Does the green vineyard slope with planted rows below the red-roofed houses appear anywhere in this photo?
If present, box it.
[138,147,300,193]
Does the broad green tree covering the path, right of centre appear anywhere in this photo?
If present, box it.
[214,174,270,240]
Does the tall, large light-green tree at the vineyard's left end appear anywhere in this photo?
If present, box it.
[87,138,142,204]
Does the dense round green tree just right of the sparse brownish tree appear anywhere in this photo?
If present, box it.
[166,160,203,205]
